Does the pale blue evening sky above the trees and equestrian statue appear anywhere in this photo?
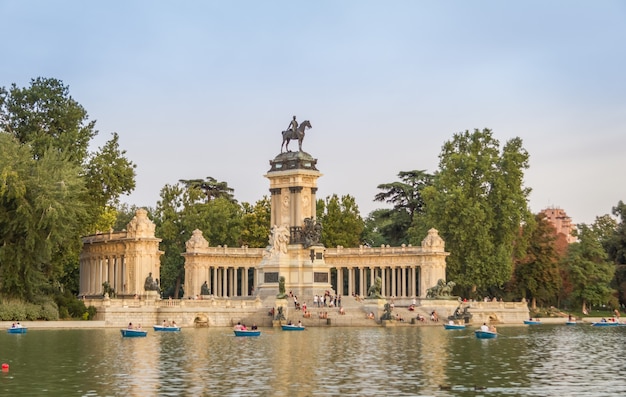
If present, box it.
[0,0,626,223]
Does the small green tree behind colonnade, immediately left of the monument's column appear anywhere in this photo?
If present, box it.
[239,196,272,248]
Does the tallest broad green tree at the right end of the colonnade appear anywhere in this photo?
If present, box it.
[420,129,532,295]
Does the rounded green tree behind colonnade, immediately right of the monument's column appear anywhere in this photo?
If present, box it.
[316,194,364,248]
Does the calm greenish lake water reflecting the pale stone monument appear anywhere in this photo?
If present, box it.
[0,325,626,396]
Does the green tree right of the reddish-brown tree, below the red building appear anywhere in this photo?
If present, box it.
[563,224,617,311]
